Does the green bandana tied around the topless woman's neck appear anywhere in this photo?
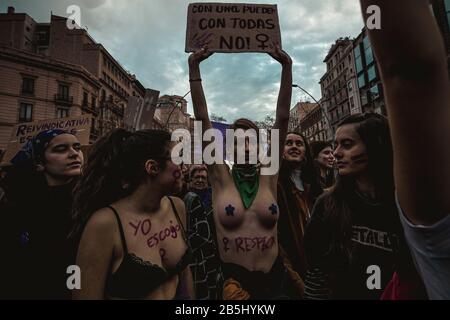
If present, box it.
[231,165,259,209]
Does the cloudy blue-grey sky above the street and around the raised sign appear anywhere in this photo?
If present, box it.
[0,0,363,122]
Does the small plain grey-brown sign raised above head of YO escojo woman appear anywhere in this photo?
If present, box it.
[124,89,159,130]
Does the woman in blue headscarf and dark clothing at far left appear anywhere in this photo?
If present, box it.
[0,129,83,299]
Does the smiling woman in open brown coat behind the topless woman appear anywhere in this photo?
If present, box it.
[277,131,323,296]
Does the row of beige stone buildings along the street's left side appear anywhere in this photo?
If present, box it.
[0,7,163,149]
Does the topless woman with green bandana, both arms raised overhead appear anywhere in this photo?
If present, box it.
[189,15,292,300]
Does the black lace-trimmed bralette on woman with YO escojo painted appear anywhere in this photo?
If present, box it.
[105,197,192,299]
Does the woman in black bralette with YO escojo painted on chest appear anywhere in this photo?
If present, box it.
[72,129,193,299]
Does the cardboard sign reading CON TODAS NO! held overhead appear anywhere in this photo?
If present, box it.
[185,3,281,52]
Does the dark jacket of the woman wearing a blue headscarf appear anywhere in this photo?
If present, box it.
[0,173,76,299]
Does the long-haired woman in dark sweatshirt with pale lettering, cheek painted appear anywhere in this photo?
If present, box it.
[305,113,422,299]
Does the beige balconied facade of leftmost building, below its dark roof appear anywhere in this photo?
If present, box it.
[0,47,100,150]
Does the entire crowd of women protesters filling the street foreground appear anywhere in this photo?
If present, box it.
[0,0,450,300]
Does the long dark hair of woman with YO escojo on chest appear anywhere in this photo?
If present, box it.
[70,129,171,237]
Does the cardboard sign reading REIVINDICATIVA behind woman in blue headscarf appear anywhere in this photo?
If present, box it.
[1,115,92,165]
